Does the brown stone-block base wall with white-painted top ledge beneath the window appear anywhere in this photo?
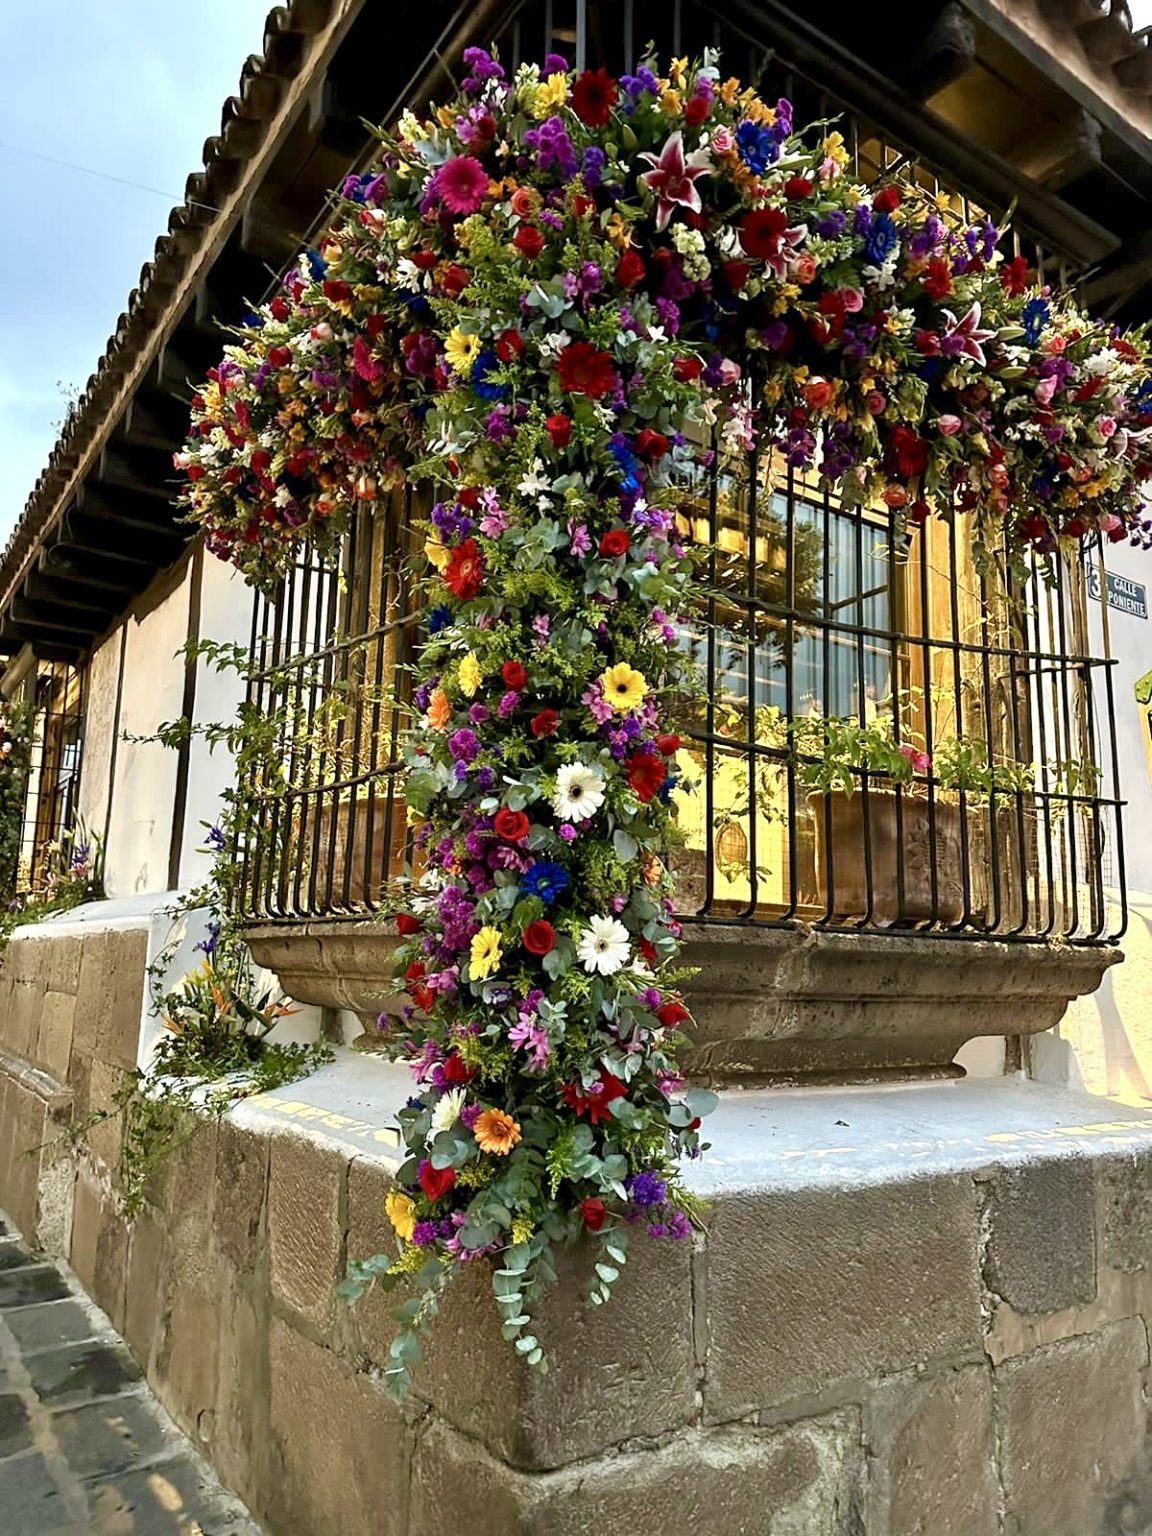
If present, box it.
[0,931,1152,1536]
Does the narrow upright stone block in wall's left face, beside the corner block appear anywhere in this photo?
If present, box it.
[267,1135,349,1327]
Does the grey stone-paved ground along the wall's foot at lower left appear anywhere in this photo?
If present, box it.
[0,1215,260,1536]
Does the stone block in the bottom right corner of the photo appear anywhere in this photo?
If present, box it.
[995,1318,1152,1536]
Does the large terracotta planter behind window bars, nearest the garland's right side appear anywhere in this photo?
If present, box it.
[808,790,971,926]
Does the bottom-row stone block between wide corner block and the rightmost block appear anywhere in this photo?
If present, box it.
[865,1366,1000,1536]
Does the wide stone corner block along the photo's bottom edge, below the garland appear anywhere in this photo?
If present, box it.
[412,1413,880,1536]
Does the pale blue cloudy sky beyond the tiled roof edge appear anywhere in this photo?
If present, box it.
[0,0,270,545]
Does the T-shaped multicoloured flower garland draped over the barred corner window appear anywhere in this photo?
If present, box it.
[177,49,1152,1392]
